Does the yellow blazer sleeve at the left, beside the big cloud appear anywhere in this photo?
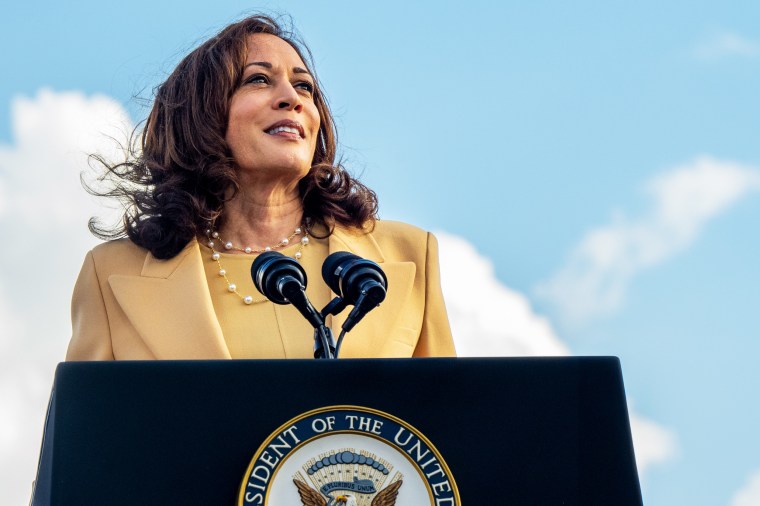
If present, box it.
[66,251,114,361]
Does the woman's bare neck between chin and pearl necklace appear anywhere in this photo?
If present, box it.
[219,184,303,249]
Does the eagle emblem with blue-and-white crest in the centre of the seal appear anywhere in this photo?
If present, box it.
[293,448,403,506]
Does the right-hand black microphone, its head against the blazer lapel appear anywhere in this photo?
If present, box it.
[322,251,388,333]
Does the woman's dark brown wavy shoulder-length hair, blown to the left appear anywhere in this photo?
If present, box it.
[88,15,377,259]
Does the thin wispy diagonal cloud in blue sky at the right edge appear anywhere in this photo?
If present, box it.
[536,157,760,322]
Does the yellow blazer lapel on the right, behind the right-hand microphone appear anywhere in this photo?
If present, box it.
[329,227,416,358]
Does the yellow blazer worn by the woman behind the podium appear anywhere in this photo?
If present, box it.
[66,221,455,360]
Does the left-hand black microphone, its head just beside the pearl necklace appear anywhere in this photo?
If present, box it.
[251,251,325,329]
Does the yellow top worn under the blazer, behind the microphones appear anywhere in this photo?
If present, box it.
[201,237,337,358]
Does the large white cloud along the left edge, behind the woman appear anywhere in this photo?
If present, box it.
[0,90,132,504]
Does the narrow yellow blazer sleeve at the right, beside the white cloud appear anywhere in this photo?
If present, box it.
[413,232,456,357]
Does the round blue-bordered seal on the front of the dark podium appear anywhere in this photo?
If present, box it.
[238,406,461,506]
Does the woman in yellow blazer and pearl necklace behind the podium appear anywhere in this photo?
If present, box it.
[67,16,454,360]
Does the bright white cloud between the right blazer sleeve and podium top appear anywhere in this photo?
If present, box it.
[436,232,569,356]
